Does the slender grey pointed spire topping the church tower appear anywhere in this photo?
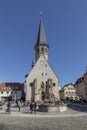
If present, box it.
[36,12,47,44]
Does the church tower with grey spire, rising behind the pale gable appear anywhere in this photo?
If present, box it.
[35,14,49,62]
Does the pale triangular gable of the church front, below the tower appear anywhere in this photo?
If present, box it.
[26,55,59,80]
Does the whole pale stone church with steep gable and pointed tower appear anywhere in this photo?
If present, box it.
[25,16,59,102]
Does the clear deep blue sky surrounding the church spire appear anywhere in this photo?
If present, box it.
[0,0,87,86]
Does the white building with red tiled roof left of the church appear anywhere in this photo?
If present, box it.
[0,82,24,101]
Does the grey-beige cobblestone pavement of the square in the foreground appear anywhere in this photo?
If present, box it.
[0,105,87,130]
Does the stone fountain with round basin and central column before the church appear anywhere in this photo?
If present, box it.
[38,80,67,112]
